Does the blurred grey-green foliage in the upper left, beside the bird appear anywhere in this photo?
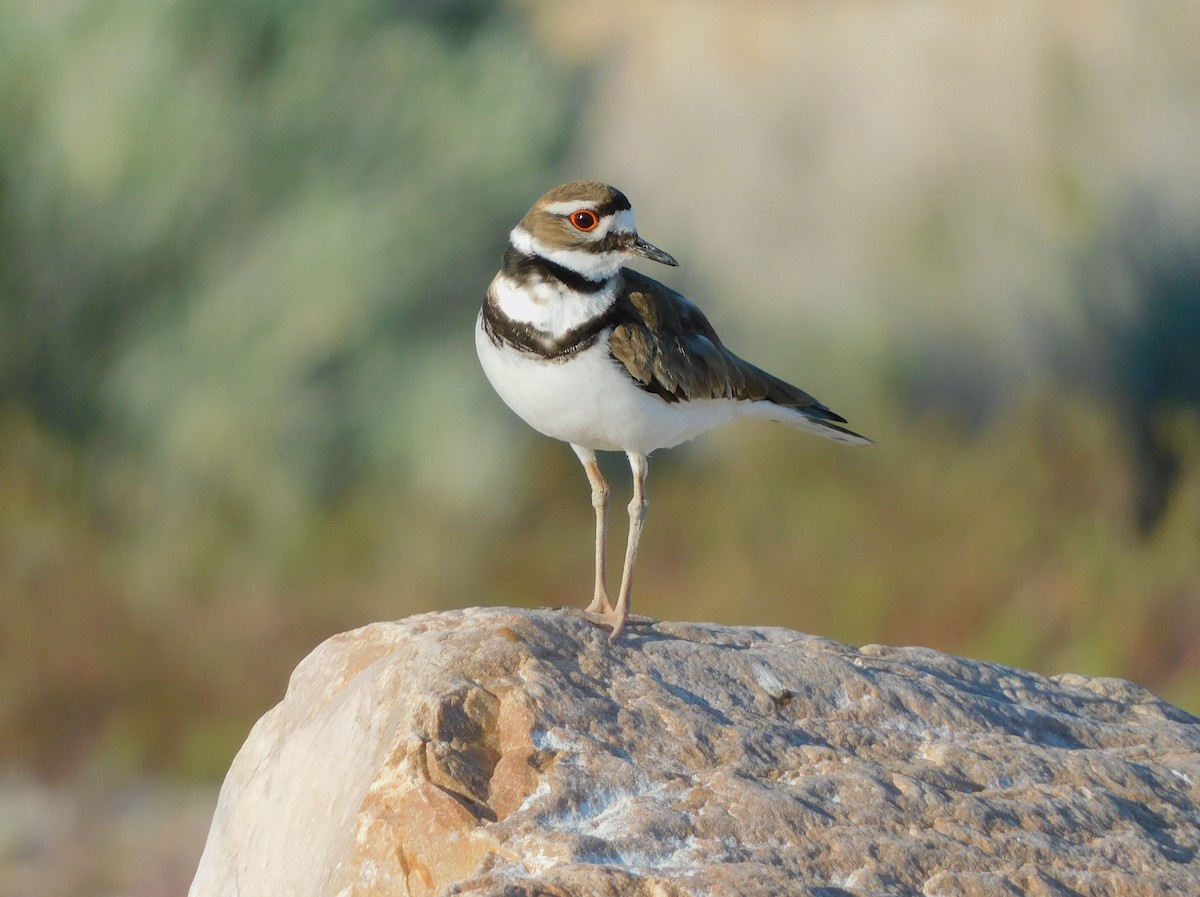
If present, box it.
[0,0,571,570]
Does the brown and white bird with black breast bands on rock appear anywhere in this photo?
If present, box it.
[475,181,871,640]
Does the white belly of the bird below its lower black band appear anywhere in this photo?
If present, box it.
[475,320,756,454]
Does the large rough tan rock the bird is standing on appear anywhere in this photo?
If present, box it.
[191,608,1200,897]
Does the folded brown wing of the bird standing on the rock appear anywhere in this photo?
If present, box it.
[611,269,845,422]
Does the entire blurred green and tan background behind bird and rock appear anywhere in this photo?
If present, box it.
[0,0,1200,897]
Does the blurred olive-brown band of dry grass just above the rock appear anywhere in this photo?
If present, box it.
[0,393,1200,778]
